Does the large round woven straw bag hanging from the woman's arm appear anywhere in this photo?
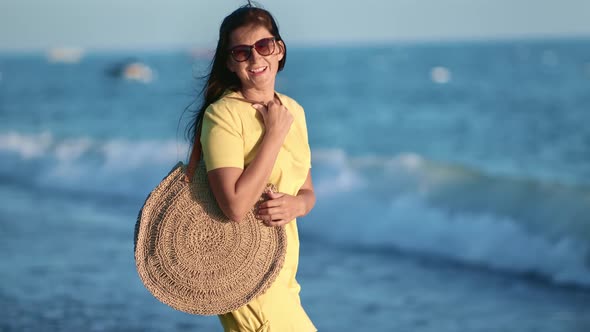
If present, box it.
[135,162,287,315]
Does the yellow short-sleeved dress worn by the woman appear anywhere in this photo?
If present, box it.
[201,91,317,332]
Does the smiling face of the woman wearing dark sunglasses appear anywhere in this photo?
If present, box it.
[227,25,283,91]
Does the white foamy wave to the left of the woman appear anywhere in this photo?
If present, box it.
[0,132,188,196]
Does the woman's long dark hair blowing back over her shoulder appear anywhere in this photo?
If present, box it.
[187,2,287,144]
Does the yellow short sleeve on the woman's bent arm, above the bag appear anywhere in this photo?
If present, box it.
[201,104,244,171]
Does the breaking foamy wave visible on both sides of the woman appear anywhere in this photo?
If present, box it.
[0,133,590,287]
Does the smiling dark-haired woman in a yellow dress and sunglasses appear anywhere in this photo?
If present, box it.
[192,5,316,332]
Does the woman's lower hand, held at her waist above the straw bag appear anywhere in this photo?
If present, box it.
[256,192,305,227]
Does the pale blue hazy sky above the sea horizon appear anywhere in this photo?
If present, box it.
[0,0,590,51]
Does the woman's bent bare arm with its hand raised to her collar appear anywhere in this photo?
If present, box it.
[207,102,293,221]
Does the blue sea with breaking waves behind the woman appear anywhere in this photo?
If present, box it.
[0,39,590,332]
